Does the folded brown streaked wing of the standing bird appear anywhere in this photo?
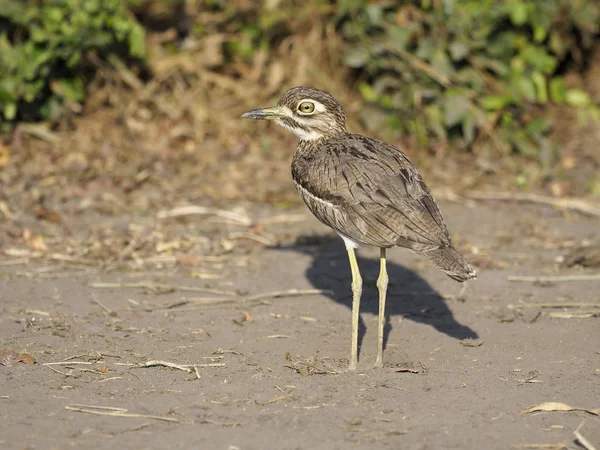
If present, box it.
[295,135,451,251]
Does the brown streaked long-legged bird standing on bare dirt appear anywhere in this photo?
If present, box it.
[242,86,477,371]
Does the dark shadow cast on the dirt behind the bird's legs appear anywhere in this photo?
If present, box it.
[279,235,478,358]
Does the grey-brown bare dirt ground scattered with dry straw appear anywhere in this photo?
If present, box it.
[0,201,600,450]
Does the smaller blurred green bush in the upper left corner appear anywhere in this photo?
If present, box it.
[0,0,144,129]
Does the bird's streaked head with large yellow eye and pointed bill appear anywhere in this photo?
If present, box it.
[242,86,346,141]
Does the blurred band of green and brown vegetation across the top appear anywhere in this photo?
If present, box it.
[0,0,600,162]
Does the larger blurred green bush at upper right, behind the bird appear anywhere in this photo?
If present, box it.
[338,0,600,155]
